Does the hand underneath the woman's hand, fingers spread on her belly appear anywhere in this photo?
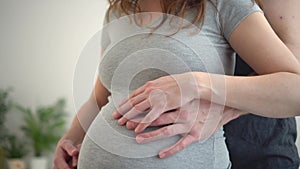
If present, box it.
[122,99,242,158]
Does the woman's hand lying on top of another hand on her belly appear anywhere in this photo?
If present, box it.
[113,72,199,133]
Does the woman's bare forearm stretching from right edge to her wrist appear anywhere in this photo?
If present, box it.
[195,72,300,118]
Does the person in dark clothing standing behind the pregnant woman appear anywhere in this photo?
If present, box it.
[117,0,300,169]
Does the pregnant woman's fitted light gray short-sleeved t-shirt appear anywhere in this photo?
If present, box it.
[79,0,261,169]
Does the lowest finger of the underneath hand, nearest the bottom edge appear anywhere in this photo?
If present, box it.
[158,135,197,158]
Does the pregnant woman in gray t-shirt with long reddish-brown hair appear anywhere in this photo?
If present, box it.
[55,0,300,169]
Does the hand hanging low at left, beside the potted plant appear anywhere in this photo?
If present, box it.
[54,137,81,169]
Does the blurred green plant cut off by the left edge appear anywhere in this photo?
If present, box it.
[0,89,11,169]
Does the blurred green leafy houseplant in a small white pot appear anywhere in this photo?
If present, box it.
[16,99,66,169]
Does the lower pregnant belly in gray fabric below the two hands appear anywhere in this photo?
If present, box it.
[78,97,229,169]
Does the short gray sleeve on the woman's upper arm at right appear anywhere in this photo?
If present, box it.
[216,0,262,40]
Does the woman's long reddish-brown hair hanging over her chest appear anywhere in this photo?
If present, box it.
[106,0,261,26]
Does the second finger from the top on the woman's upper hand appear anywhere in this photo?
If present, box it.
[118,100,150,125]
